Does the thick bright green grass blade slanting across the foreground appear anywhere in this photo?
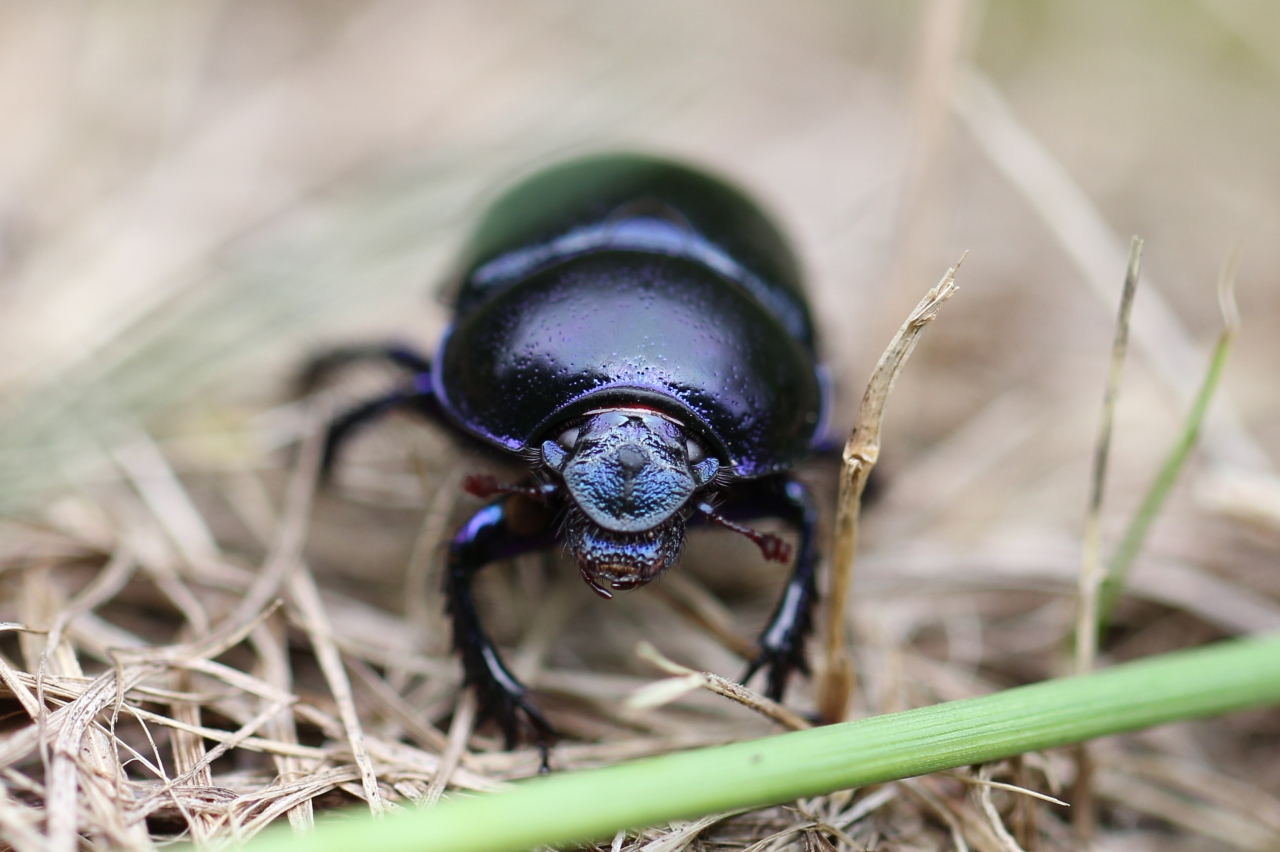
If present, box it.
[238,637,1280,852]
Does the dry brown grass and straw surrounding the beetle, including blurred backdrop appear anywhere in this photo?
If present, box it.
[0,0,1280,852]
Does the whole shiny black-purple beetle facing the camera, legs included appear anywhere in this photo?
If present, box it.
[303,155,831,765]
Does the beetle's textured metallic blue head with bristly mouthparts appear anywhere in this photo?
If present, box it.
[543,408,719,597]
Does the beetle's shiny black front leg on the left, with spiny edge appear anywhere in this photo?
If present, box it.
[444,494,556,766]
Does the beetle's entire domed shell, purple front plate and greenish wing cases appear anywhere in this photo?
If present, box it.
[433,156,827,477]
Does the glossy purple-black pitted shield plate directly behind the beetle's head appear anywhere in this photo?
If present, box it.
[433,252,824,477]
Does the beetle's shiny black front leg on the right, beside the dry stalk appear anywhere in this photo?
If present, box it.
[701,476,818,701]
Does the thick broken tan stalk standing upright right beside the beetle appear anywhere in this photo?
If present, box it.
[818,252,968,722]
